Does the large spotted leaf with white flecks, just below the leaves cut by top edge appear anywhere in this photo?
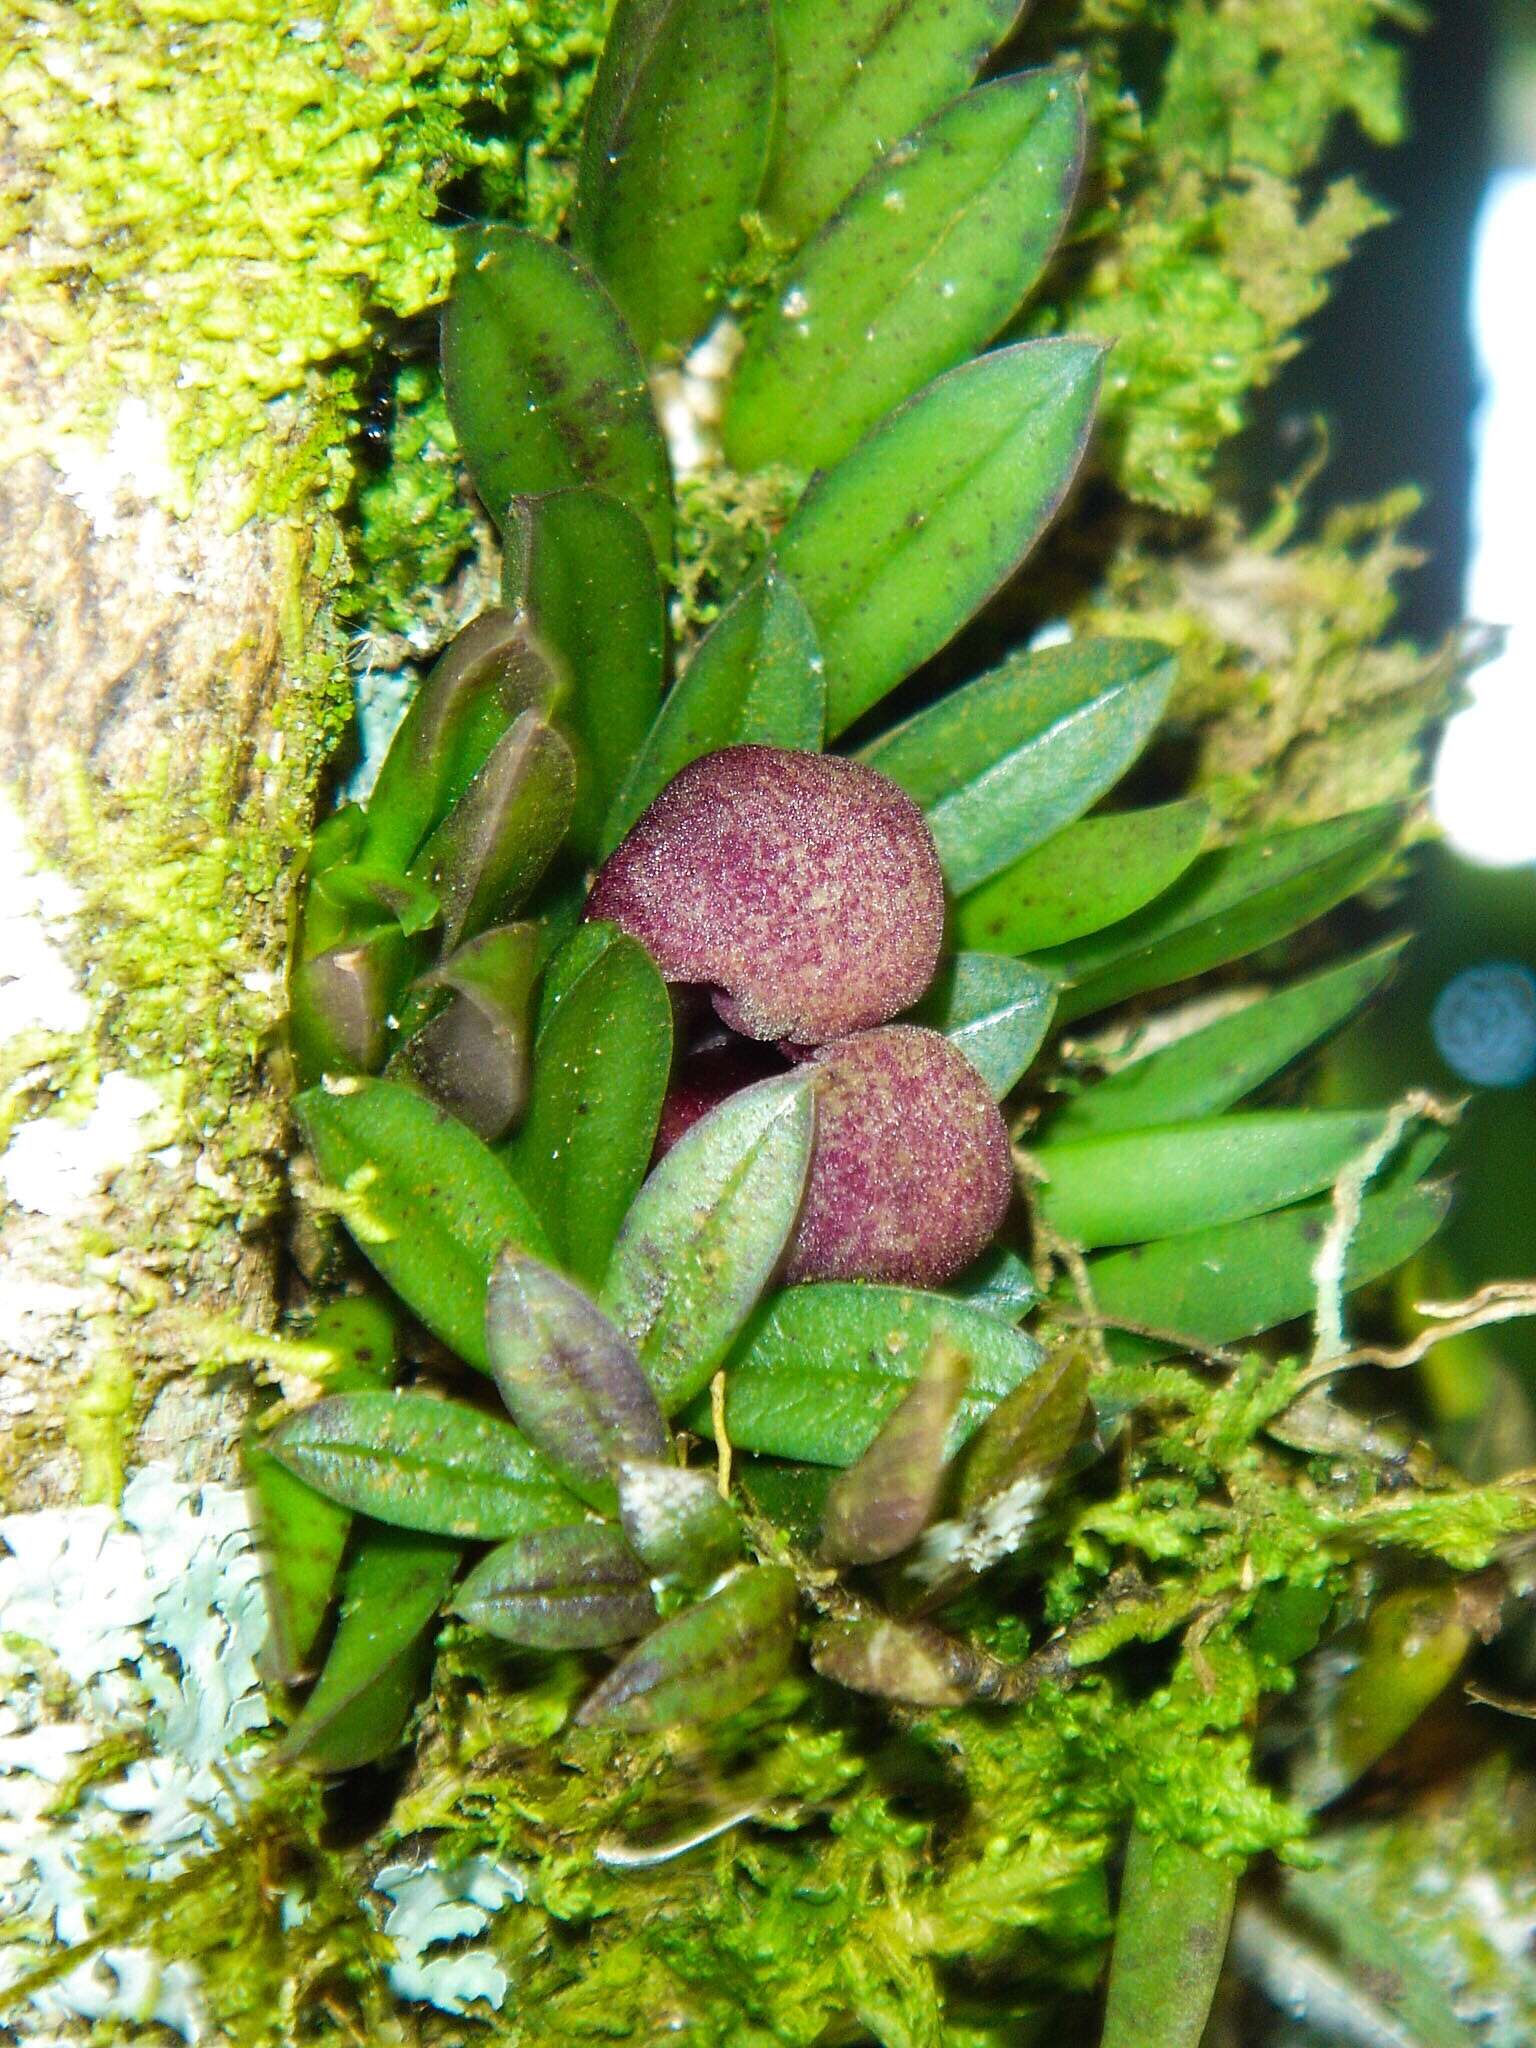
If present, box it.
[725,72,1083,471]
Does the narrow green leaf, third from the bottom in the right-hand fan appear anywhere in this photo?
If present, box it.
[1051,940,1405,1141]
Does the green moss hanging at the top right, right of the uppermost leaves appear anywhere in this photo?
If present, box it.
[1026,0,1417,512]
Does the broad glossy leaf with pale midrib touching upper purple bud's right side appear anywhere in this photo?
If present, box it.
[862,639,1176,893]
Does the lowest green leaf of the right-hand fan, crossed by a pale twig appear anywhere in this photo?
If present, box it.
[1087,1182,1450,1356]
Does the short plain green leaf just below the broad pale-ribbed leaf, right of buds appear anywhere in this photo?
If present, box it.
[954,799,1210,952]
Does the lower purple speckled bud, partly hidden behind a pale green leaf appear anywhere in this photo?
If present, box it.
[784,1024,1014,1286]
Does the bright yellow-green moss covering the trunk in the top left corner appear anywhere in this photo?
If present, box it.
[0,0,602,498]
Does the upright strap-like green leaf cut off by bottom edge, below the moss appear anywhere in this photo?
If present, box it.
[1102,1827,1239,2048]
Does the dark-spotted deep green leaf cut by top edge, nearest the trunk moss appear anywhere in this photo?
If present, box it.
[571,0,774,354]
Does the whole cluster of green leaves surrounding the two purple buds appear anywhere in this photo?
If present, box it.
[262,0,1466,2031]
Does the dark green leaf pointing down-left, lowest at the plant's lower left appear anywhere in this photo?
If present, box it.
[272,1526,461,1772]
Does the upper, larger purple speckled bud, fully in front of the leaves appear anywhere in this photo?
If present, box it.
[586,745,944,1044]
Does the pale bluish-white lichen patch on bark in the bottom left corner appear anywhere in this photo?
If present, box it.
[0,1464,268,2040]
